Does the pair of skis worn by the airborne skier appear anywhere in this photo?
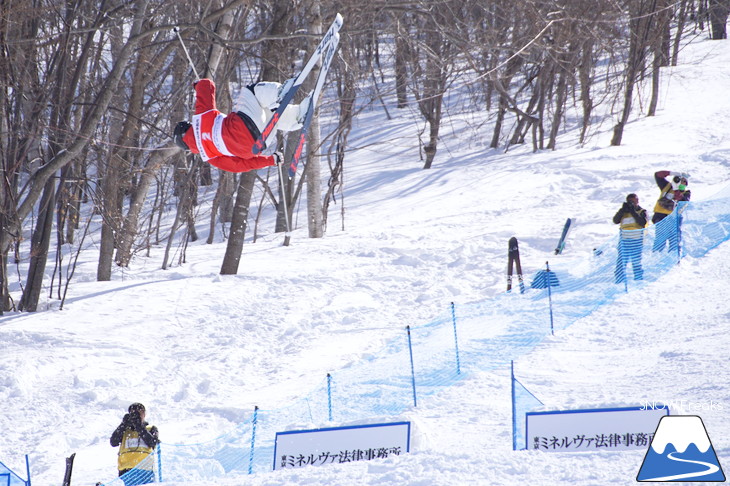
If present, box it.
[252,13,343,178]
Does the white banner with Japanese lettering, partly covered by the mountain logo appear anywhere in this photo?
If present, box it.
[525,407,669,452]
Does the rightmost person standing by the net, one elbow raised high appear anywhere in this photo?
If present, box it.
[651,170,691,252]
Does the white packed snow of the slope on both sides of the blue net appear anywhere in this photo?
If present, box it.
[0,35,730,486]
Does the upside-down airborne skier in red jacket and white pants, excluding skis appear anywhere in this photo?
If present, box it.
[173,79,310,172]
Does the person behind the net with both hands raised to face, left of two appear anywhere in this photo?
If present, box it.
[613,193,647,283]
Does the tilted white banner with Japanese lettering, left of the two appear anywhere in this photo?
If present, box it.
[274,422,411,470]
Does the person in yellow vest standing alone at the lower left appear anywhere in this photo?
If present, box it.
[109,403,160,486]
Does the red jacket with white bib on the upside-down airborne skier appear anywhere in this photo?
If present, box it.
[183,79,275,172]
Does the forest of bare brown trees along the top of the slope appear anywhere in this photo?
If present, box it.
[0,0,730,312]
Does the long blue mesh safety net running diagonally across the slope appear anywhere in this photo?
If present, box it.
[98,188,730,486]
